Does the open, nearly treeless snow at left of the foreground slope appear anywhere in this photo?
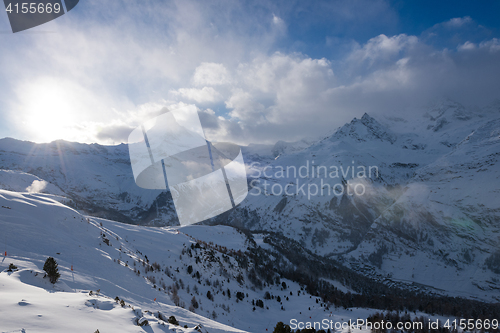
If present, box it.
[0,191,252,332]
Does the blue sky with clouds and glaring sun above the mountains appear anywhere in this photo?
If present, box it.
[0,0,500,144]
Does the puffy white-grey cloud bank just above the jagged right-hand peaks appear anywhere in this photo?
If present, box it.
[94,35,500,144]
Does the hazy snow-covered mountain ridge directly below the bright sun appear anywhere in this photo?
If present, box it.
[0,138,176,225]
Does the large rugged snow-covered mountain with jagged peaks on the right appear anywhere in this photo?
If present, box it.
[218,100,500,300]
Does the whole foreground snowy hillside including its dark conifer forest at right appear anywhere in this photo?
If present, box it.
[0,190,500,333]
